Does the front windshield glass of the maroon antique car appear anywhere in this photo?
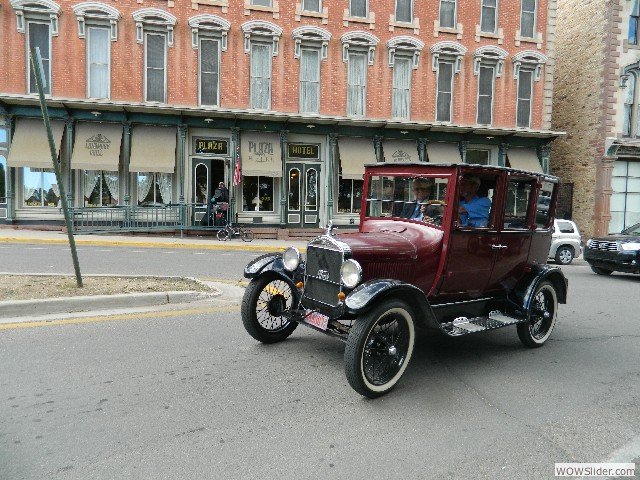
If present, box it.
[366,175,448,219]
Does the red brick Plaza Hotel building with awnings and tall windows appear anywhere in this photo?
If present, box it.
[0,0,558,229]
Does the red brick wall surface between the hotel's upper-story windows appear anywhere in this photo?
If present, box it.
[0,0,547,128]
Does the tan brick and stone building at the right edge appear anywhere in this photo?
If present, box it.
[551,0,640,238]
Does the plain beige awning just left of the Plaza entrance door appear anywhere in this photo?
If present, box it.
[129,125,177,173]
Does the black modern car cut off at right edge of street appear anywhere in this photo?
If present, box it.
[584,223,640,275]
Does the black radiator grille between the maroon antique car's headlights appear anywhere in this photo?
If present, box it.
[303,246,344,307]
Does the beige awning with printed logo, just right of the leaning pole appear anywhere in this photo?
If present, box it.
[71,123,122,172]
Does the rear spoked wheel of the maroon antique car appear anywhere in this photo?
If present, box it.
[518,282,558,348]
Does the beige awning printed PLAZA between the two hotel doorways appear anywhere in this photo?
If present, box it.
[240,132,282,177]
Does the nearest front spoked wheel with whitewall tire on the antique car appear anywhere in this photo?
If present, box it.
[344,300,415,398]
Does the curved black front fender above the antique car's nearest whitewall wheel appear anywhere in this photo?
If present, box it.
[344,279,439,328]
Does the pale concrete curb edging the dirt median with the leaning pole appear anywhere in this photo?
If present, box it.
[0,287,222,320]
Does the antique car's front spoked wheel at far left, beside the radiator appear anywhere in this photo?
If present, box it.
[240,273,298,343]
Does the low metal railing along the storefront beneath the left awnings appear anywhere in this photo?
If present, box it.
[70,203,228,234]
